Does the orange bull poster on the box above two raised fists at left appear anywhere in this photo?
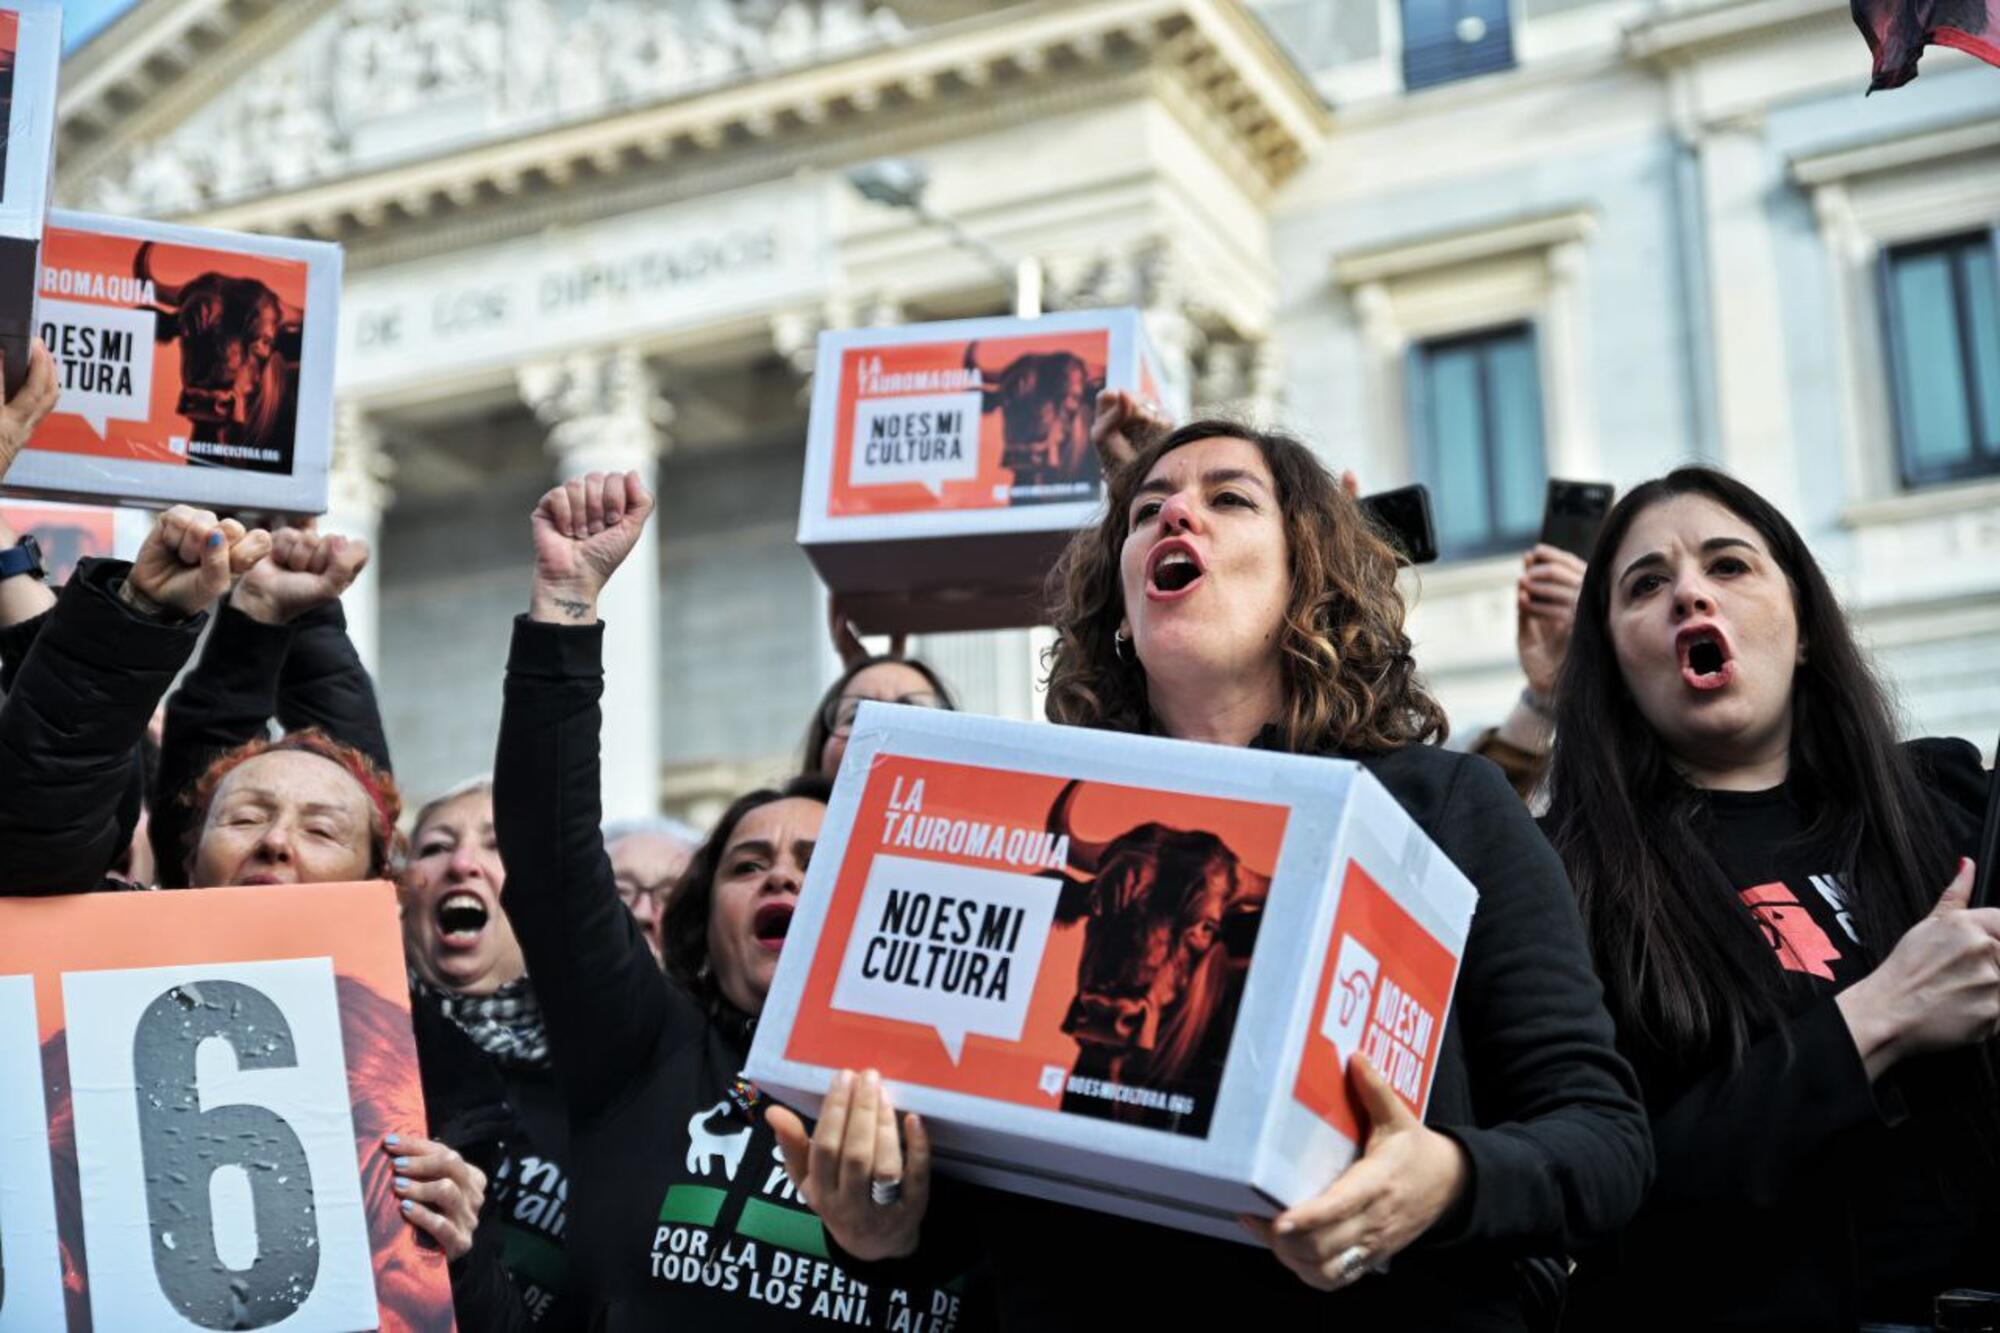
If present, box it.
[34,224,310,474]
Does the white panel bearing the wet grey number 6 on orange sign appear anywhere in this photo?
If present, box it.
[62,959,380,1333]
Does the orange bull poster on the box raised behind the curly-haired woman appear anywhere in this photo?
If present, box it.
[826,330,1110,516]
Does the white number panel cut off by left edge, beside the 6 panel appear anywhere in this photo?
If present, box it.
[0,977,68,1333]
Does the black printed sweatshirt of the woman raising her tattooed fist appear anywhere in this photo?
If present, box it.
[494,616,964,1333]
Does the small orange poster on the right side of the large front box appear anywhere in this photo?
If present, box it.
[1292,861,1458,1141]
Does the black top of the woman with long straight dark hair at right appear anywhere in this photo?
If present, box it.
[1576,741,2000,1329]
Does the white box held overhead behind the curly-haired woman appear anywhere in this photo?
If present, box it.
[798,310,1176,630]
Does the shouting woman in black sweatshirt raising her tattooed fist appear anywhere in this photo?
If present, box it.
[494,474,976,1333]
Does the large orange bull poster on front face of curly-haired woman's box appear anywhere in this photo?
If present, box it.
[786,755,1288,1135]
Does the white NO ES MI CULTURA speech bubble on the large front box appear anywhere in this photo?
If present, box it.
[832,857,1062,1065]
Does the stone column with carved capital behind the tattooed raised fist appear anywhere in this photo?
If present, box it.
[518,346,672,819]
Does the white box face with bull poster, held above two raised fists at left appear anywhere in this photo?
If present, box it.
[6,210,340,514]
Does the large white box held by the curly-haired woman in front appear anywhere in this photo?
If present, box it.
[748,705,1476,1239]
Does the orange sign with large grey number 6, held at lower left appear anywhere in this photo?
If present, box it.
[0,885,454,1333]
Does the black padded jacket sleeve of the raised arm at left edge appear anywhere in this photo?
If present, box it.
[0,558,208,893]
